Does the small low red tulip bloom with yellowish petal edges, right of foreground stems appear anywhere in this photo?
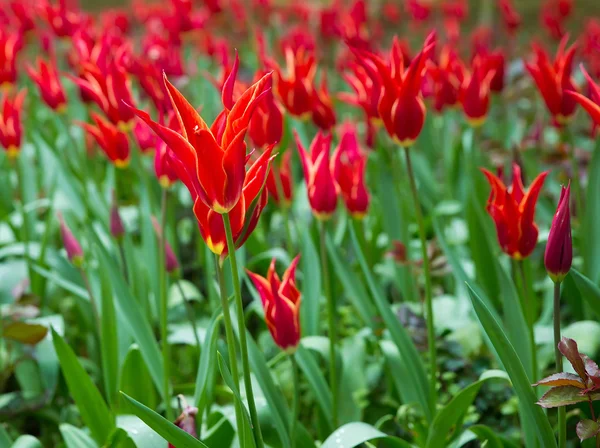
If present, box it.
[246,255,302,353]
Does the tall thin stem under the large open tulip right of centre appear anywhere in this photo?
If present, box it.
[404,148,437,412]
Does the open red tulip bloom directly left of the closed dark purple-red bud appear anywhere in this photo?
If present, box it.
[482,163,548,260]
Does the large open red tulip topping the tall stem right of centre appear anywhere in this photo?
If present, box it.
[354,33,435,147]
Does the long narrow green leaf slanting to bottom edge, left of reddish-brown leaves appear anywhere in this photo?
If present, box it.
[468,285,556,448]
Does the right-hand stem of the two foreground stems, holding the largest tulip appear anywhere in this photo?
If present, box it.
[223,213,265,448]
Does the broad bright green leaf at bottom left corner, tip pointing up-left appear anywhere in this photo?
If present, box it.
[52,329,115,444]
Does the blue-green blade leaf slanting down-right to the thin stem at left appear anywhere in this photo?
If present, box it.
[92,232,164,390]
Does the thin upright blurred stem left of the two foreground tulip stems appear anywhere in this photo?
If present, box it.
[157,189,173,420]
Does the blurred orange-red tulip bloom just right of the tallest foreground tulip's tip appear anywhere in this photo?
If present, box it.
[266,47,317,118]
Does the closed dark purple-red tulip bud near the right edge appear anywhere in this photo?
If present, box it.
[544,185,573,283]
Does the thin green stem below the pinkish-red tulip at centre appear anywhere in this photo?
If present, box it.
[319,221,338,428]
